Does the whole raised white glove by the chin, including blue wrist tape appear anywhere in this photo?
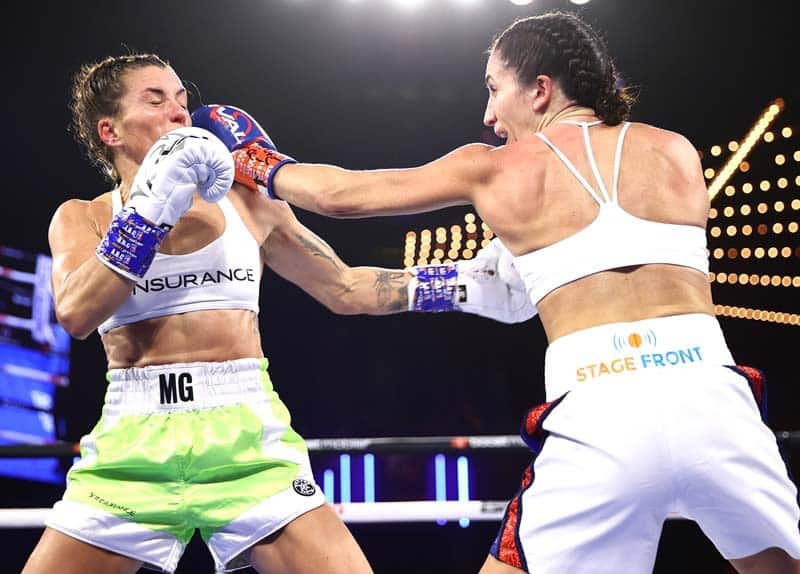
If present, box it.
[96,128,234,281]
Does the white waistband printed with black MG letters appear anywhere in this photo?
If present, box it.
[104,359,272,415]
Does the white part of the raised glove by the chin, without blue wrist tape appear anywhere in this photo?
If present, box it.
[125,127,234,230]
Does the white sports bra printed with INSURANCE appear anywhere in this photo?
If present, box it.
[97,189,261,335]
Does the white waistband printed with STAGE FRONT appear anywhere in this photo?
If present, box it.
[545,313,734,401]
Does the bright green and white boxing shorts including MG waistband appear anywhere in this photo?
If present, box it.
[46,359,325,572]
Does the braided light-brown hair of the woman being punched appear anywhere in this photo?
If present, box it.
[69,54,169,183]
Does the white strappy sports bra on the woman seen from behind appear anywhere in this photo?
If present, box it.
[514,121,708,305]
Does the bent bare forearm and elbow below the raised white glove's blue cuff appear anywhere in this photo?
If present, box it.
[54,257,134,339]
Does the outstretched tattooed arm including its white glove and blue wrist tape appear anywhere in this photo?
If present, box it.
[262,202,536,323]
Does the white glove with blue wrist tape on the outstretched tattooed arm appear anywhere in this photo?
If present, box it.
[408,238,537,323]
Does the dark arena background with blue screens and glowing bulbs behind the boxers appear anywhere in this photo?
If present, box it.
[0,0,800,574]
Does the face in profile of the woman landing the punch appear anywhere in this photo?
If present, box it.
[483,50,537,143]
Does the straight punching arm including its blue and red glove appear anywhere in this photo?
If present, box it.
[192,105,497,218]
